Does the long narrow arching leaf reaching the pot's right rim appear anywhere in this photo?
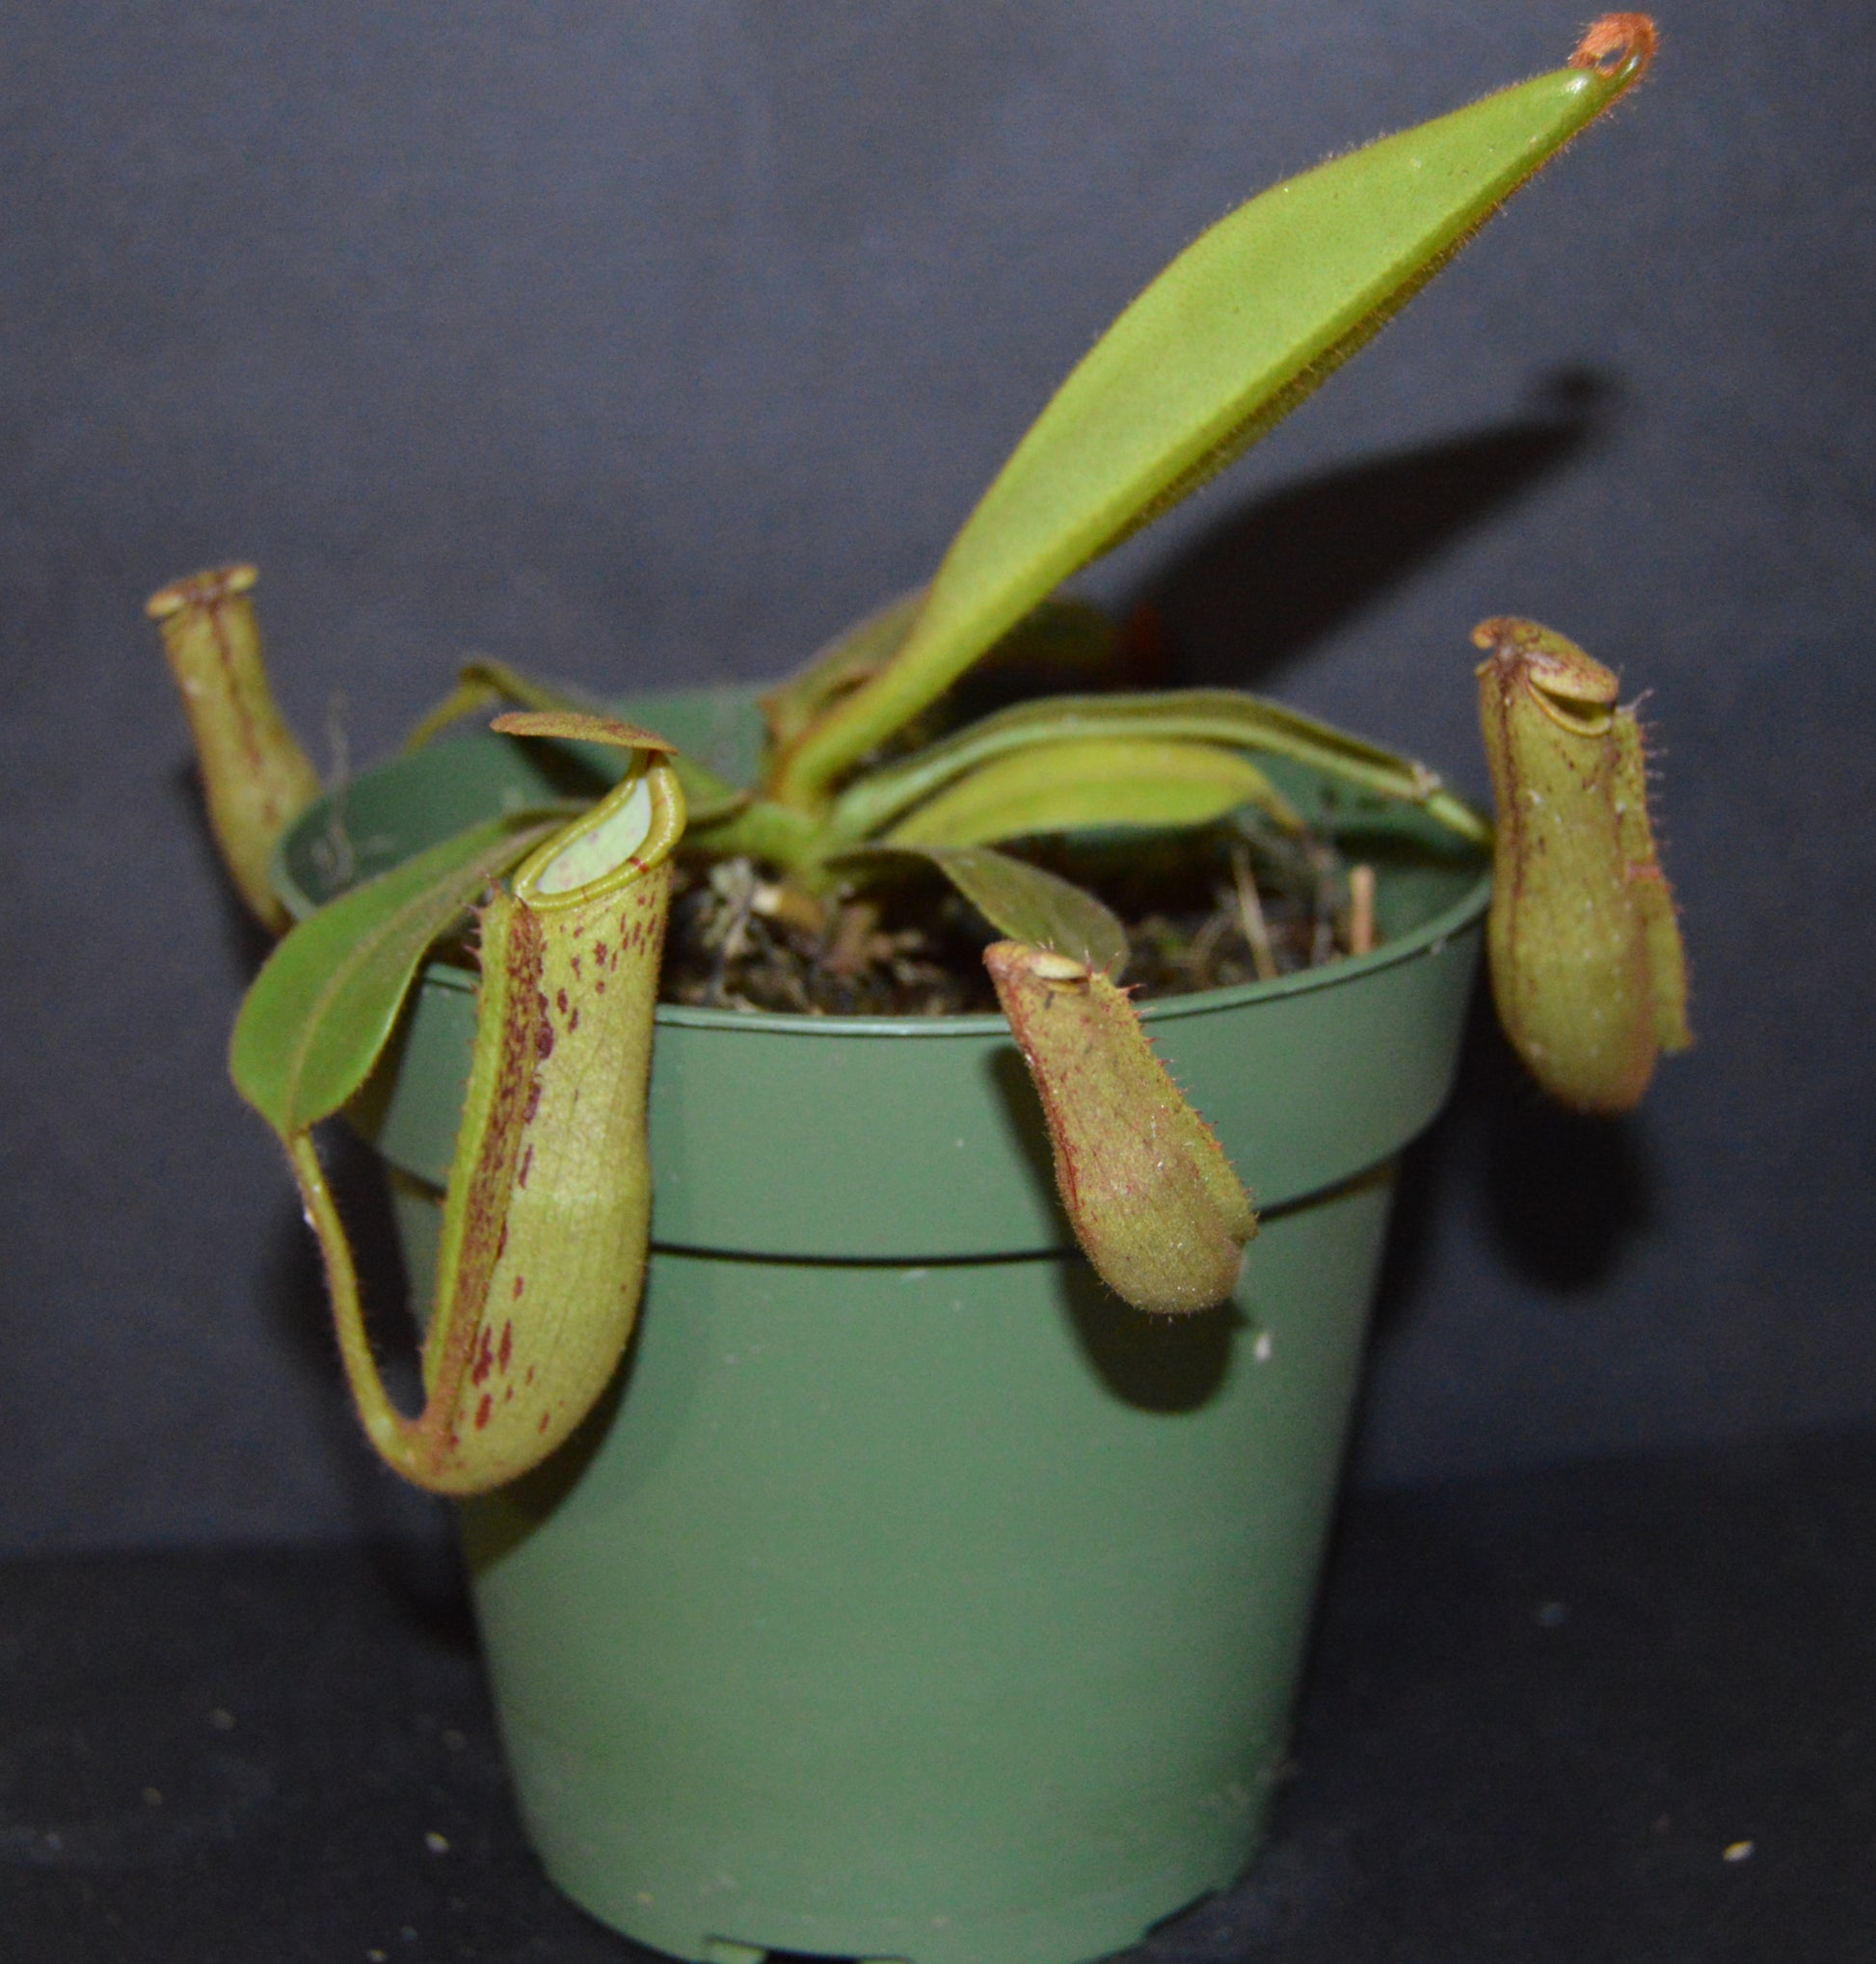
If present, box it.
[827,689,1491,843]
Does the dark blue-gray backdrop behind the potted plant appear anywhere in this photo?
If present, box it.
[0,0,1876,1547]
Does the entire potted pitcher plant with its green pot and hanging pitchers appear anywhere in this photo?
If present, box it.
[151,13,1687,1964]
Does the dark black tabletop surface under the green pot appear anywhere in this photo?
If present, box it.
[0,1432,1876,1964]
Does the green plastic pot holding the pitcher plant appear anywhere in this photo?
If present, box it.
[279,695,1487,1964]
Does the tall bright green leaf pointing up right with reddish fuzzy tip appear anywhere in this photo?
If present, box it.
[774,15,1652,807]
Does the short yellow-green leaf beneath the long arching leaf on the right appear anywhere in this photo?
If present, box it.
[884,737,1297,847]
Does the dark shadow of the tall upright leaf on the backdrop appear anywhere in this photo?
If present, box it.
[1130,369,1622,687]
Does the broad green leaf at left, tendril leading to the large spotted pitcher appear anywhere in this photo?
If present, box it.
[228,813,564,1137]
